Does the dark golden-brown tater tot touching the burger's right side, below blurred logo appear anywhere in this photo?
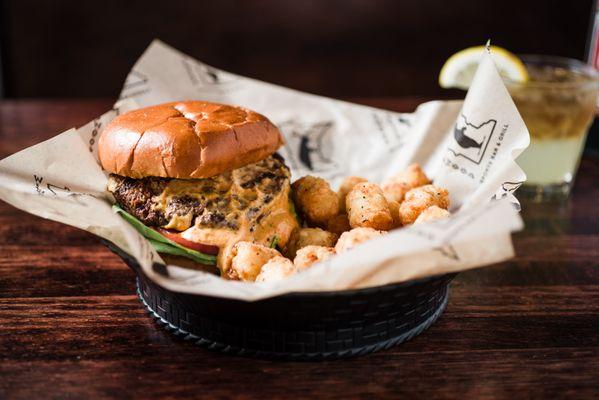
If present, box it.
[291,175,339,226]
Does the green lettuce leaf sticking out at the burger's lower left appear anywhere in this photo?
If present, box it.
[112,204,216,265]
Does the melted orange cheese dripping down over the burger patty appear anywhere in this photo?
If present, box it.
[152,157,297,277]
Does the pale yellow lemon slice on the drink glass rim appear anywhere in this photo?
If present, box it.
[439,46,528,90]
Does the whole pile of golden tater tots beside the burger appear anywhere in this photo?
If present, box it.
[231,164,450,282]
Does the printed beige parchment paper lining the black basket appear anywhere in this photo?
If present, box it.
[0,41,529,300]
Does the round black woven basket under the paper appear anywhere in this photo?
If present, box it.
[107,243,455,360]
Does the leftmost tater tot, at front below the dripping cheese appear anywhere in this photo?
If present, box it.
[227,242,281,281]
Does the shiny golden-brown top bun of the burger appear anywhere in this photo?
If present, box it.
[98,101,283,179]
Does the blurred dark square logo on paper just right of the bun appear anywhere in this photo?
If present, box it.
[279,120,337,172]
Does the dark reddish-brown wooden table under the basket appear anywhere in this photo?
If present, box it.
[0,99,599,399]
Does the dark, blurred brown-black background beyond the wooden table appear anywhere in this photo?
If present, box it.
[0,0,594,99]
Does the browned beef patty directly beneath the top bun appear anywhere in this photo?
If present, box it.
[108,154,290,231]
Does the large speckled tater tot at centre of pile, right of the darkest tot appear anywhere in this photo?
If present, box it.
[345,182,393,231]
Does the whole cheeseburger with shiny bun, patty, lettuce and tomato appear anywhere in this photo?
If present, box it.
[98,101,298,279]
